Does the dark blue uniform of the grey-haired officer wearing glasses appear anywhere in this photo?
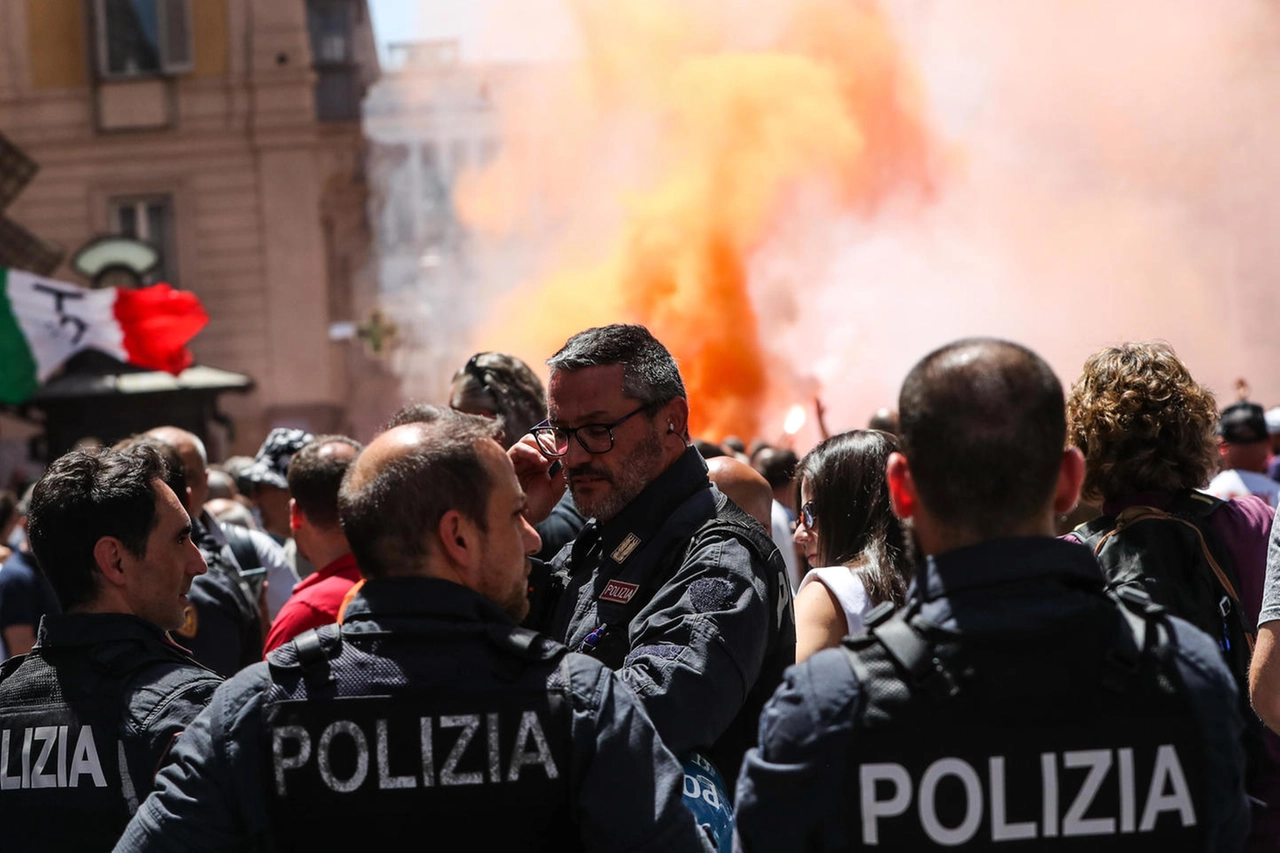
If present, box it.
[529,447,795,780]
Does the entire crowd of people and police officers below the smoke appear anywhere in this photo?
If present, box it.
[0,325,1280,852]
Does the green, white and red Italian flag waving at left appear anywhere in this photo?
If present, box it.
[0,268,209,403]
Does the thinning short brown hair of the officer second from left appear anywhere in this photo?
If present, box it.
[338,410,500,578]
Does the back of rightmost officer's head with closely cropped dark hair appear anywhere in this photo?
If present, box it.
[899,338,1066,539]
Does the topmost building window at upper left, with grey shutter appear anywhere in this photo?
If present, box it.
[93,0,193,79]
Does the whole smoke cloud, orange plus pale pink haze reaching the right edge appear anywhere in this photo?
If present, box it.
[448,0,1280,442]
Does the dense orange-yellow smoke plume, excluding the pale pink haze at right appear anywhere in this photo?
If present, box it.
[460,0,932,437]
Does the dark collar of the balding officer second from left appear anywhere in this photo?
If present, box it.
[343,578,515,625]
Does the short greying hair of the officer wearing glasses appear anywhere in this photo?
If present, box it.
[547,324,689,406]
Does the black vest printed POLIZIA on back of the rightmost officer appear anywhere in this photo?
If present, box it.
[845,588,1207,853]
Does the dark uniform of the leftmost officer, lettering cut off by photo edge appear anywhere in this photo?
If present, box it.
[0,613,221,850]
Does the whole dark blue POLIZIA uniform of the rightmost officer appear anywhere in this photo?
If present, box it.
[737,538,1248,853]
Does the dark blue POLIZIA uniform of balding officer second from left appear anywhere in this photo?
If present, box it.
[118,578,704,850]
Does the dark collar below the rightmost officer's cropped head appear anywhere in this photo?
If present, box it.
[908,537,1103,601]
